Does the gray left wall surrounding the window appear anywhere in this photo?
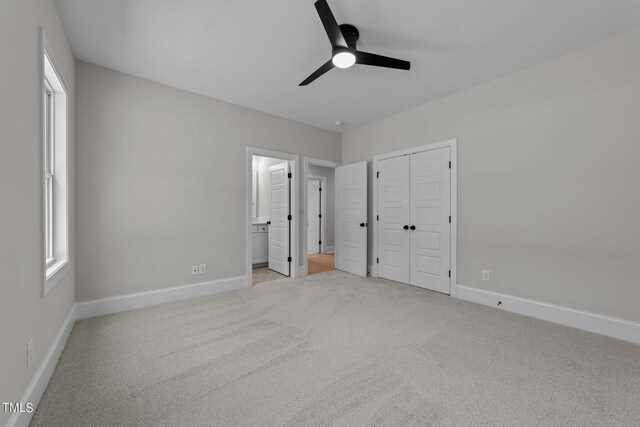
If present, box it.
[0,0,74,425]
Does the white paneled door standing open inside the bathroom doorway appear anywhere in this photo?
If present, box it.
[269,162,291,276]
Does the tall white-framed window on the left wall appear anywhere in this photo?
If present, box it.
[42,49,69,294]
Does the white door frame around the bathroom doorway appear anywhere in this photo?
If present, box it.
[244,147,300,288]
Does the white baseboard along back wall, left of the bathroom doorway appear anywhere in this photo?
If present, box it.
[76,276,247,320]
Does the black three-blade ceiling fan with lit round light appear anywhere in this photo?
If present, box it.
[299,0,411,86]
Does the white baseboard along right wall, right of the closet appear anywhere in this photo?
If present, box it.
[457,285,640,344]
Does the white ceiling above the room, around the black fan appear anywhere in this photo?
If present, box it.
[57,0,640,132]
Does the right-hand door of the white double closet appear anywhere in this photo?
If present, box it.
[410,147,451,294]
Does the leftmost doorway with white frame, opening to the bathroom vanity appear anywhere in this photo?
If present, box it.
[245,147,299,287]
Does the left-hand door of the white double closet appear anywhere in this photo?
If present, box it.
[377,156,411,283]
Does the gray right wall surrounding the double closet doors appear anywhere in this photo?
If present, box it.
[343,31,640,321]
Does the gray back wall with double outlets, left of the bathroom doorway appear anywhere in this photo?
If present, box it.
[76,62,341,301]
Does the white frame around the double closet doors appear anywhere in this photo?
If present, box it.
[371,138,458,297]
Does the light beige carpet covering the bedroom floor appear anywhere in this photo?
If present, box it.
[32,271,640,426]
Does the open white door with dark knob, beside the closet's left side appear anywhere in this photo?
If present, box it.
[336,162,367,277]
